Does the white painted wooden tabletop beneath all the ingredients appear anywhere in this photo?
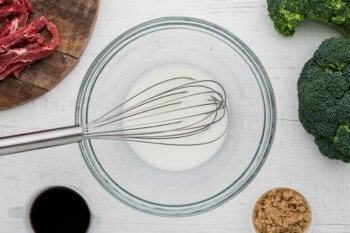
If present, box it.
[0,0,350,233]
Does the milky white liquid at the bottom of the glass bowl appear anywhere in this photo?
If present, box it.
[123,64,228,171]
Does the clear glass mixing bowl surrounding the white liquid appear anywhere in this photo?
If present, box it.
[76,17,276,217]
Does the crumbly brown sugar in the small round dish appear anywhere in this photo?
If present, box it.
[253,188,311,233]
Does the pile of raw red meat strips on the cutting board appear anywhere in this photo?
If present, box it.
[0,0,59,80]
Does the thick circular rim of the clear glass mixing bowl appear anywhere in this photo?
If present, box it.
[75,17,276,217]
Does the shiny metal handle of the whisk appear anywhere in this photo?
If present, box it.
[0,126,83,155]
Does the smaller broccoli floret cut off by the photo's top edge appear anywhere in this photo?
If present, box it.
[267,0,350,38]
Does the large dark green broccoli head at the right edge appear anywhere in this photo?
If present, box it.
[298,38,350,162]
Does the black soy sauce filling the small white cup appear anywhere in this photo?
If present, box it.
[30,187,91,233]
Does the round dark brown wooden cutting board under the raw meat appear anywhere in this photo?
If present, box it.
[0,0,99,110]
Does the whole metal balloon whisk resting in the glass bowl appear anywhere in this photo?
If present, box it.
[0,77,228,155]
